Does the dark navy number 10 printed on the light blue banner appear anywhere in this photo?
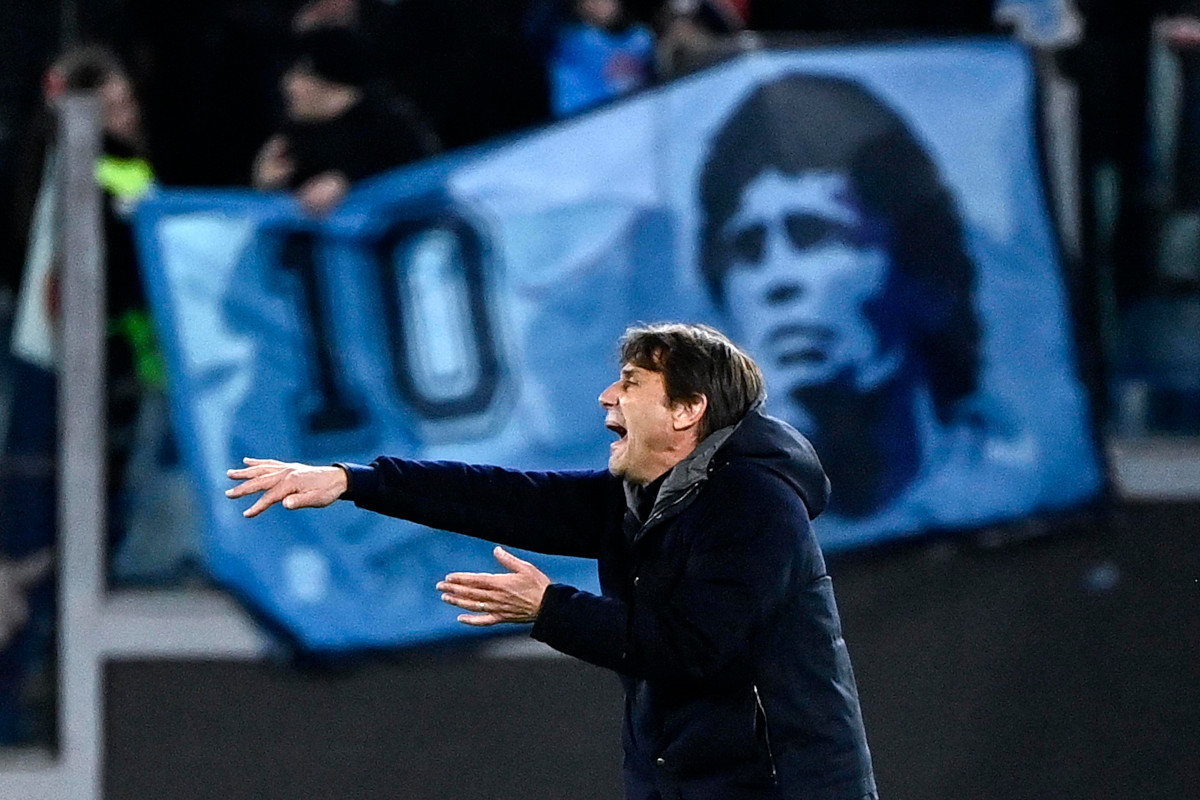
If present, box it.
[270,213,504,444]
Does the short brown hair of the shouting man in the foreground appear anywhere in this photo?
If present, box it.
[620,323,767,439]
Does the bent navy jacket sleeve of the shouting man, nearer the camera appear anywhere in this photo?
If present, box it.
[533,465,823,685]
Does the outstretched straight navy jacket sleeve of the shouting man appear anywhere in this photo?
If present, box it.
[338,457,619,558]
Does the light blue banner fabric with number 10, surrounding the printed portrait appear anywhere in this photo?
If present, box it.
[137,40,1104,650]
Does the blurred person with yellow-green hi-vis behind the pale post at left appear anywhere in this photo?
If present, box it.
[5,47,164,551]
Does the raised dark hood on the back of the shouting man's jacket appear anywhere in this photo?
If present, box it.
[709,407,829,519]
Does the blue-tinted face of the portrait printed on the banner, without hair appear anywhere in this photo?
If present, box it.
[721,169,900,392]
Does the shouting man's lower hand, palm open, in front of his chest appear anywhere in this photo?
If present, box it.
[437,547,550,625]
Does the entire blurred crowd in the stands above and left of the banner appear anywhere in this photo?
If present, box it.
[0,0,1200,744]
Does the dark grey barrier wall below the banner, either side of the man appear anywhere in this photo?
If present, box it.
[104,504,1200,800]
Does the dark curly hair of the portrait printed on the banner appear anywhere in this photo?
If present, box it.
[700,73,980,421]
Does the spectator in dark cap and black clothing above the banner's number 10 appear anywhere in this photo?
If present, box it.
[253,28,438,215]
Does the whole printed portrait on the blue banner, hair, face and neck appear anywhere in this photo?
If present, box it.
[698,74,1032,523]
